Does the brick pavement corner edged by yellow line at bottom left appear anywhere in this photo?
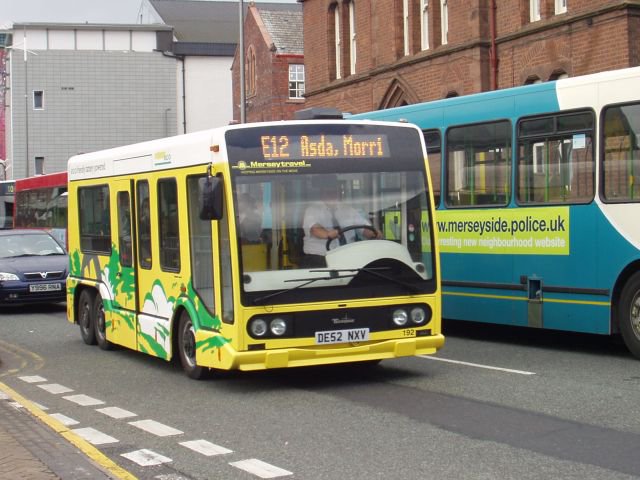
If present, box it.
[0,360,136,480]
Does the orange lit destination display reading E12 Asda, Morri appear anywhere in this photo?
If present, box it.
[260,134,390,160]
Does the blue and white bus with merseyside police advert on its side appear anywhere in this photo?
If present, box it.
[354,67,640,357]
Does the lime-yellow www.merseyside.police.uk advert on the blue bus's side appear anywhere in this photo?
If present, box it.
[436,207,570,255]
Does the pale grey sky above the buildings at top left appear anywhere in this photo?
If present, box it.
[0,0,295,26]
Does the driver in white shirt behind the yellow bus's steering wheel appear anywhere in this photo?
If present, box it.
[302,178,382,267]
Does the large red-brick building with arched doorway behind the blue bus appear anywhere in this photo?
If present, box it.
[301,0,640,113]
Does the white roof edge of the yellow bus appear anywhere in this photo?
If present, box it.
[68,119,416,181]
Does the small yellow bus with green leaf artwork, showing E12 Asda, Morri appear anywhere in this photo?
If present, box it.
[67,120,444,379]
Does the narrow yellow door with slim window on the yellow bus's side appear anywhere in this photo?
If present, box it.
[107,180,137,349]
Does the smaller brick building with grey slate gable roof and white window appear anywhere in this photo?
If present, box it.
[232,3,305,122]
